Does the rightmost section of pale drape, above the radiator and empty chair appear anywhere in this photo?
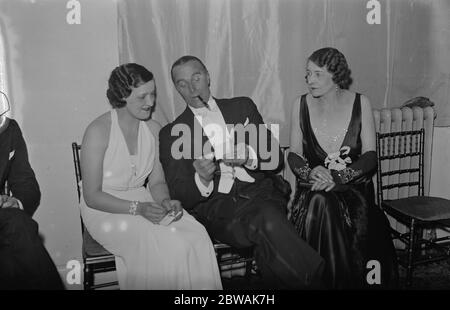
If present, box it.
[385,0,450,126]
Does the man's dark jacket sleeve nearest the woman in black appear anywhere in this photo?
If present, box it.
[246,98,284,172]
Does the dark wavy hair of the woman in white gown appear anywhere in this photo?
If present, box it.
[106,63,153,109]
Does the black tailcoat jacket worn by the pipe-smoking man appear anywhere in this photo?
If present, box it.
[159,97,283,210]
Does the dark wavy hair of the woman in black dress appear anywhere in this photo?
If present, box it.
[308,47,353,89]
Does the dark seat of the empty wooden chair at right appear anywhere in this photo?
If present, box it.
[383,196,450,222]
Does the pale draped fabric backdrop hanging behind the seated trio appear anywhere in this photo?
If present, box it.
[118,0,450,145]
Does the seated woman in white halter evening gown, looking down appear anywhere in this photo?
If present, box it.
[80,63,222,289]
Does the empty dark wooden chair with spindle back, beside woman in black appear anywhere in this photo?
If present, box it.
[376,128,450,287]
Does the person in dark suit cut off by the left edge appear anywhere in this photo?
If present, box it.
[0,116,64,290]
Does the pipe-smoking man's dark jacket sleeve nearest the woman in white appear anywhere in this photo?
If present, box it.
[159,126,208,210]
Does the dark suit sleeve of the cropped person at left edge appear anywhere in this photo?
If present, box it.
[7,122,41,216]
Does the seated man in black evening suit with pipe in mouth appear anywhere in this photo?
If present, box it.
[159,56,324,289]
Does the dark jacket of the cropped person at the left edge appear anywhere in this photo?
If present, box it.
[0,119,41,216]
